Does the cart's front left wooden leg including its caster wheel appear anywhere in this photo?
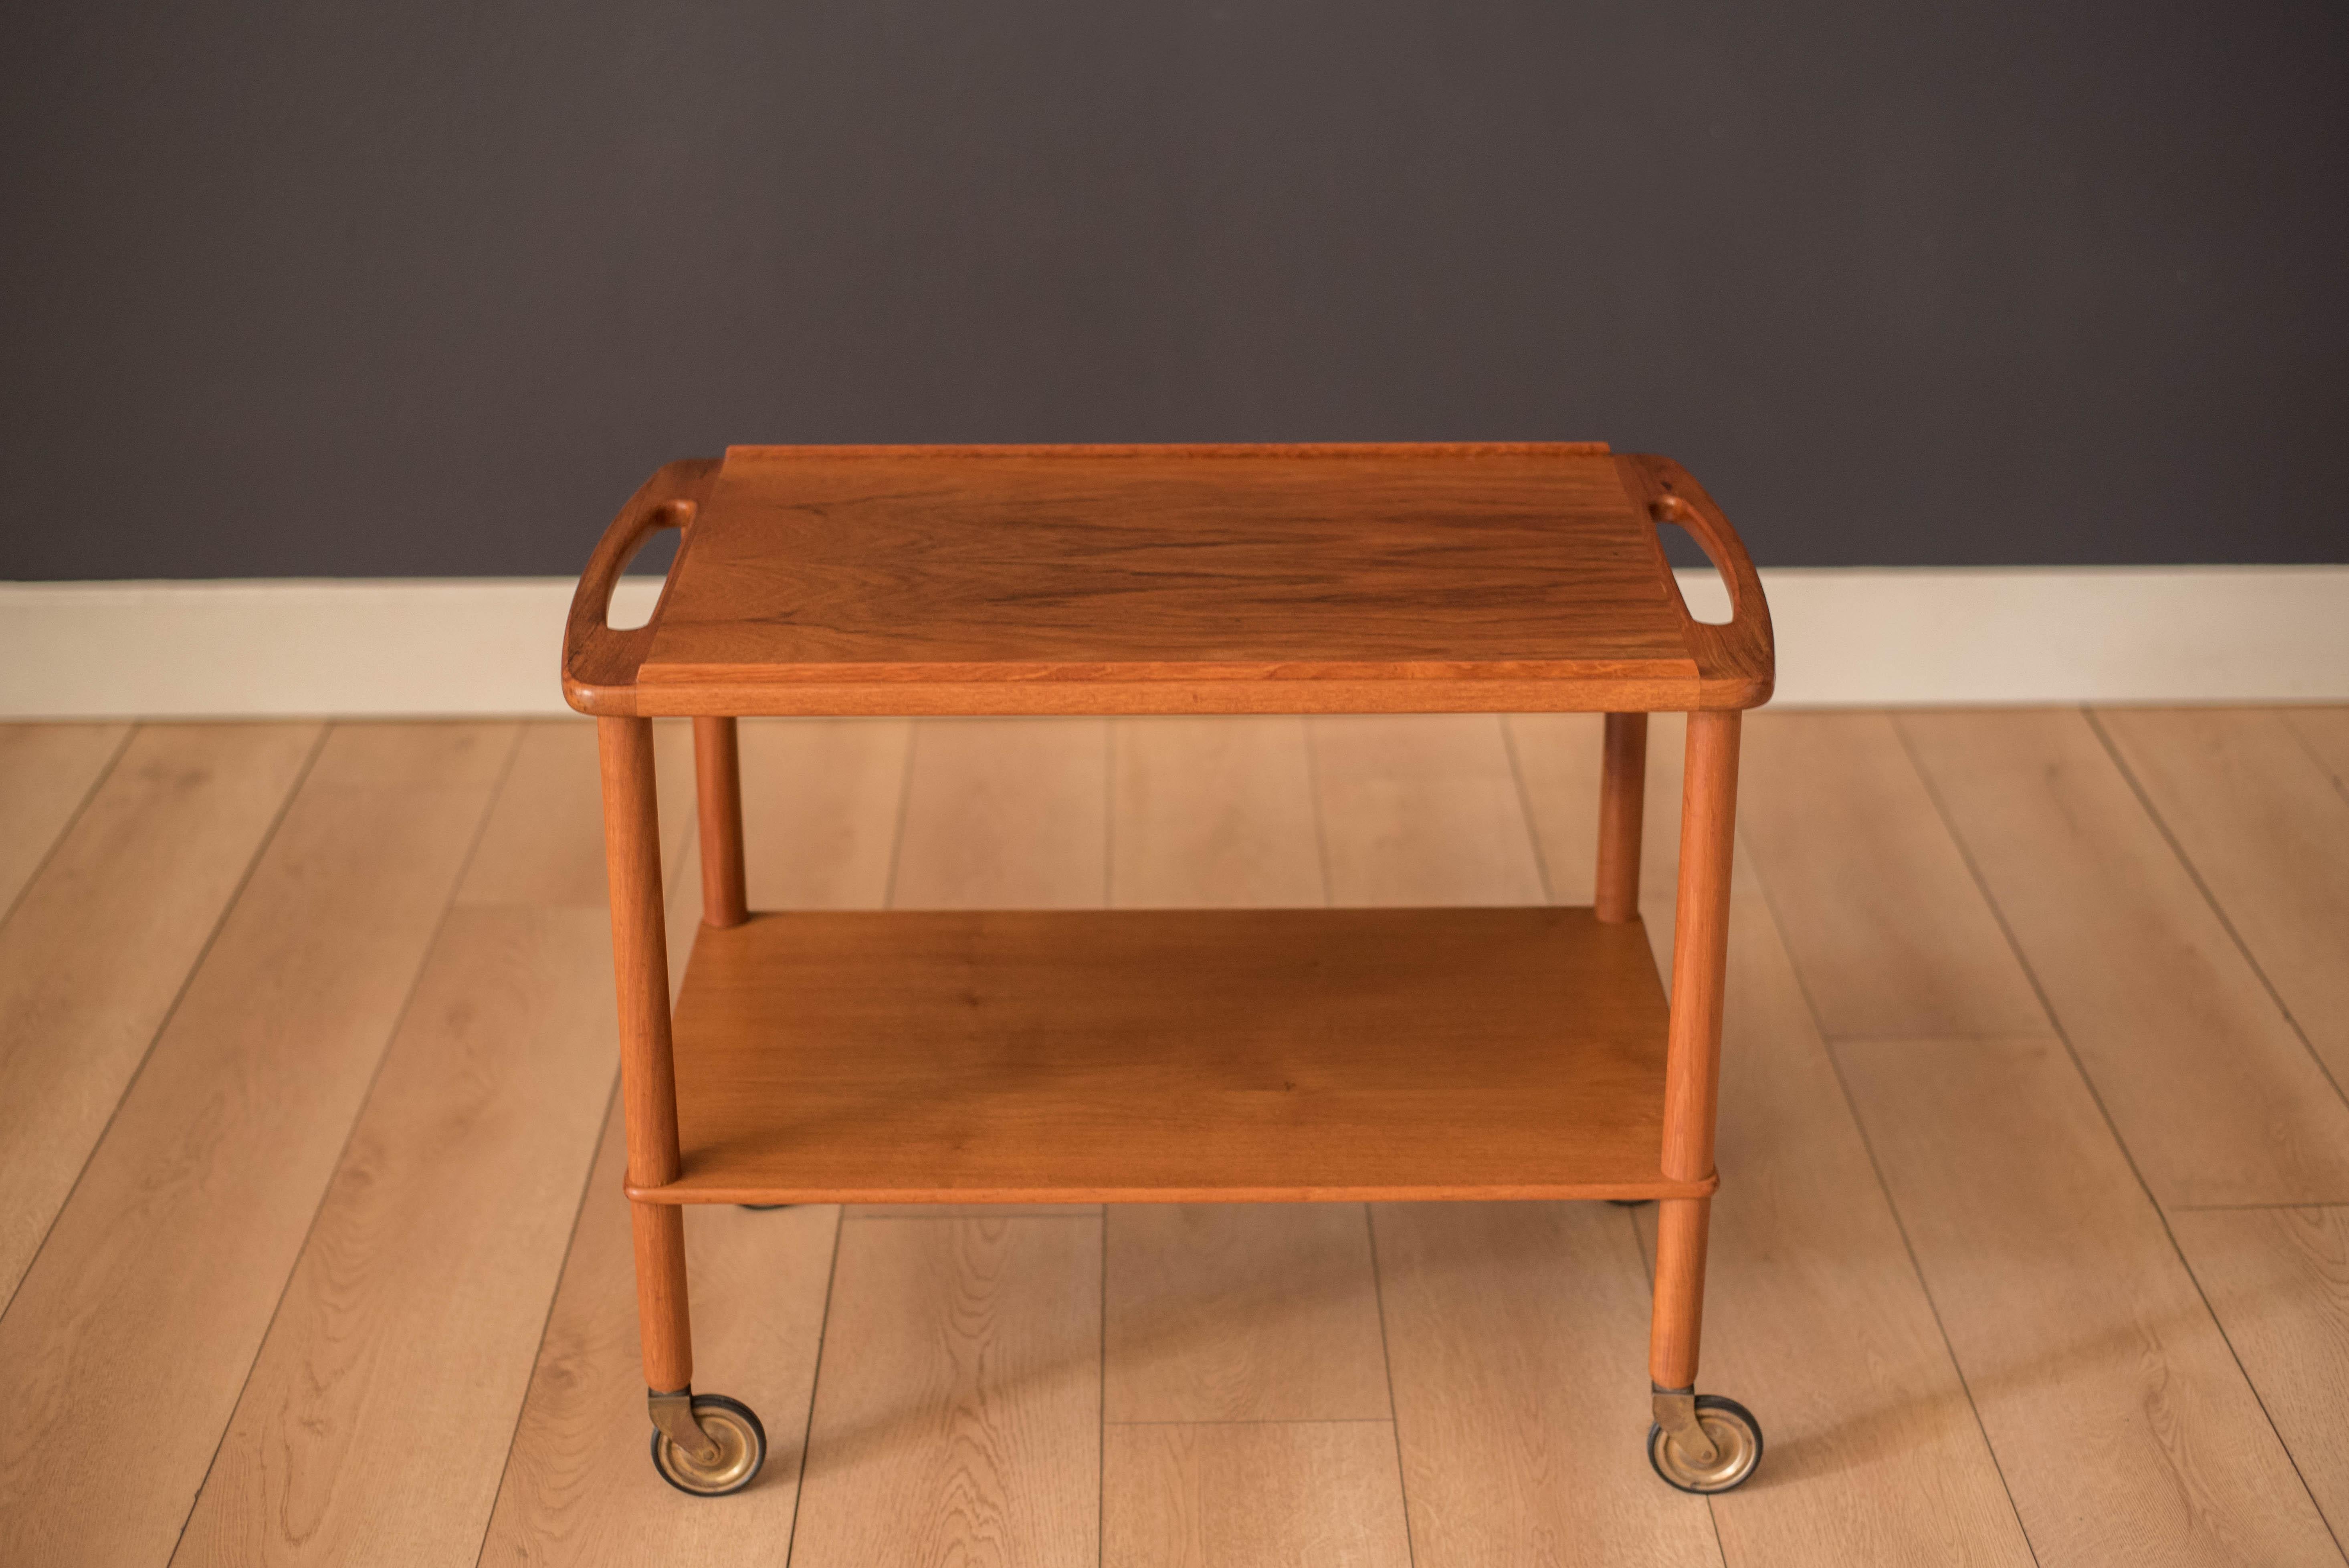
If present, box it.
[597,718,766,1495]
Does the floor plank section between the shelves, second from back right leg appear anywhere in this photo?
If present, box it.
[1306,716,1550,906]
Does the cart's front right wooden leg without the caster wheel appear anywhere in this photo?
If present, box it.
[1649,714,1738,1390]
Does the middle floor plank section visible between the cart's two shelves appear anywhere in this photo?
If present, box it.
[1109,716,1325,908]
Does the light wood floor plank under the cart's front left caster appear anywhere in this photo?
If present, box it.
[482,1103,841,1568]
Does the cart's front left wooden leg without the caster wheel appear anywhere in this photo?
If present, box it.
[597,718,693,1392]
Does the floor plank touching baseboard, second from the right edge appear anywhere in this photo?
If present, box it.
[2098,709,2349,1084]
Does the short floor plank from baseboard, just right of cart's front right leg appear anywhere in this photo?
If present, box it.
[1741,714,2046,1037]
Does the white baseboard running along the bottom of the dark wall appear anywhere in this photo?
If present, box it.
[0,566,2349,718]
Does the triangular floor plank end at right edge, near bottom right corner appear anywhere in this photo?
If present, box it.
[2171,1209,2349,1542]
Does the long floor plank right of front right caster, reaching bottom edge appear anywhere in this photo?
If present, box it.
[1642,882,2030,1566]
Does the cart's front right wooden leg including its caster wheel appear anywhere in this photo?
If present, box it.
[1609,714,1762,1493]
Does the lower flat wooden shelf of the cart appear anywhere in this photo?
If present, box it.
[630,908,1715,1204]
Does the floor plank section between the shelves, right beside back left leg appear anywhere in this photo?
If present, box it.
[740,718,914,908]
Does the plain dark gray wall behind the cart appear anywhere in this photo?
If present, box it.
[0,0,2349,577]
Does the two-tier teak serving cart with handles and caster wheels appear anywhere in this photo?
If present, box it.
[564,444,1773,1495]
